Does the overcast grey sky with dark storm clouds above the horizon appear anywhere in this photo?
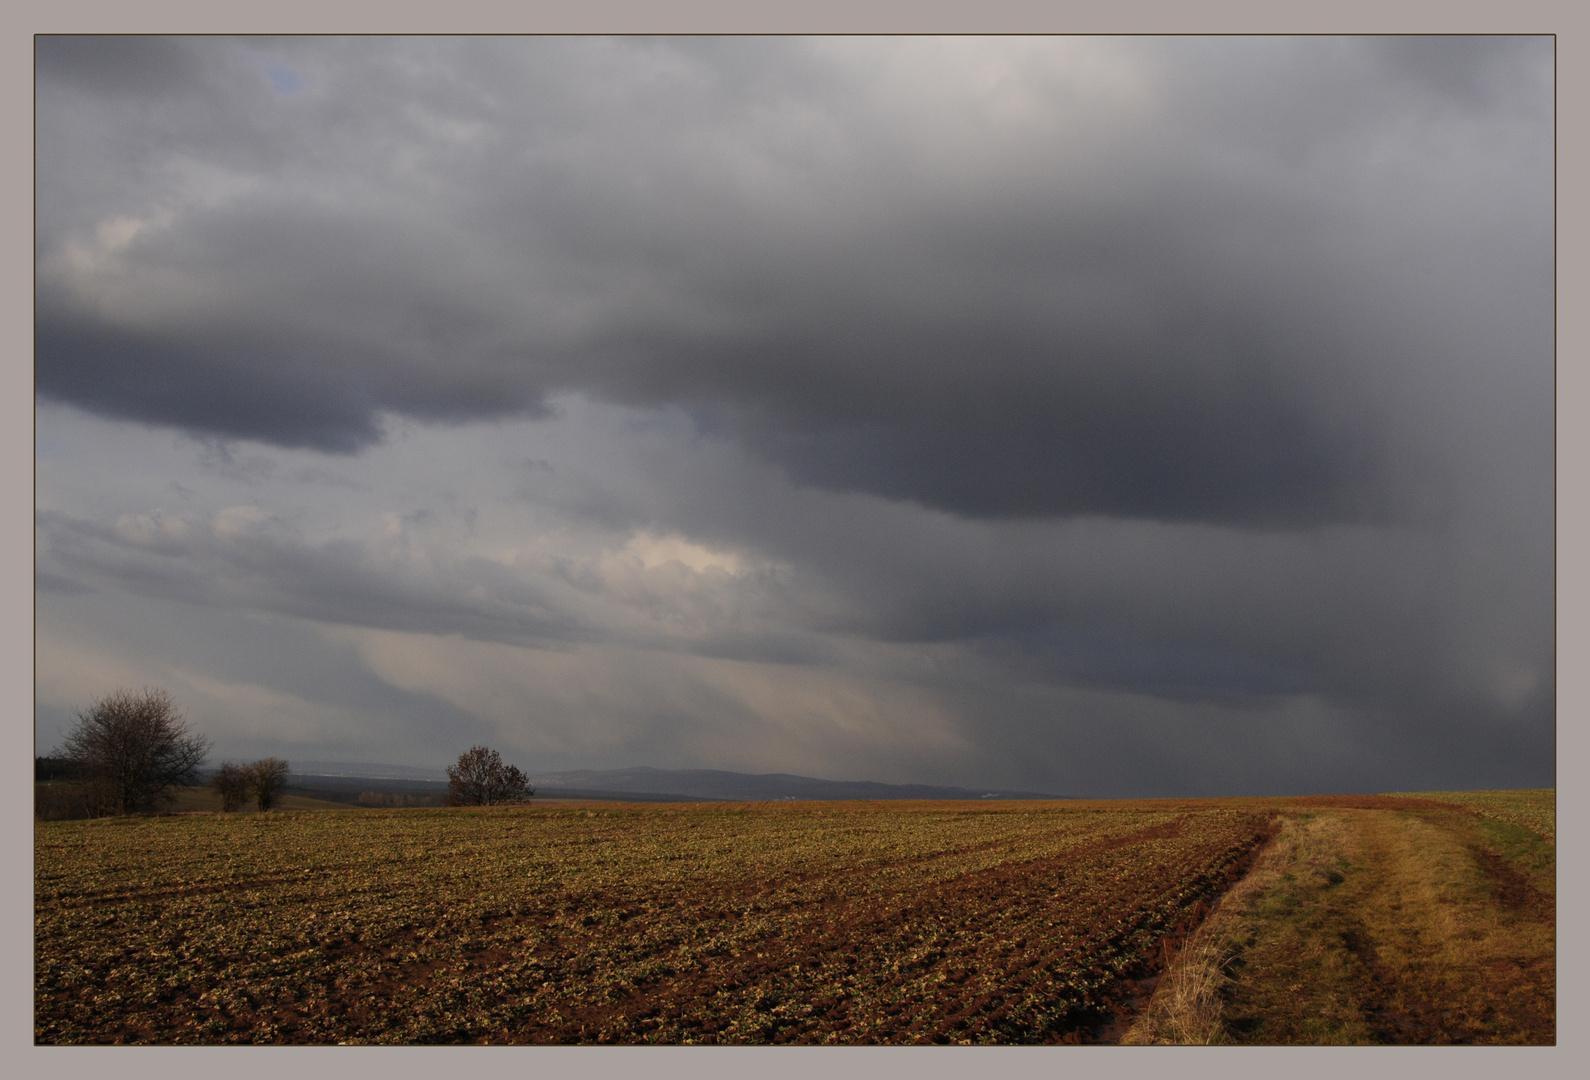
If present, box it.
[33,37,1555,797]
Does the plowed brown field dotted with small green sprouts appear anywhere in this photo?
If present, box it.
[35,802,1272,1043]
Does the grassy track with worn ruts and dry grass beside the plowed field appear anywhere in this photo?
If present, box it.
[1124,808,1555,1045]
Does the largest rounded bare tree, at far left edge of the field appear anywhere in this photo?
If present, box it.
[57,687,210,814]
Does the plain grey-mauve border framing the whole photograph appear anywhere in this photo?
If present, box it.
[9,8,1590,1080]
